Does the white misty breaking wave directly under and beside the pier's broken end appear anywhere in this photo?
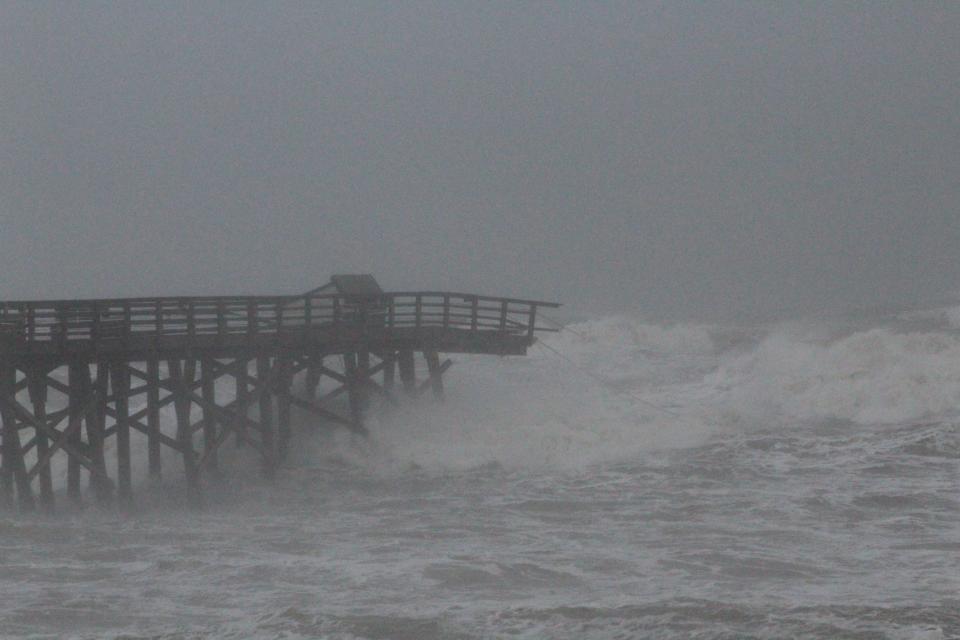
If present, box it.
[314,316,713,469]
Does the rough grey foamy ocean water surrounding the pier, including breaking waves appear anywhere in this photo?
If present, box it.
[0,307,960,640]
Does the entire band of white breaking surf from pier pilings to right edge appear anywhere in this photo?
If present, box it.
[312,308,960,471]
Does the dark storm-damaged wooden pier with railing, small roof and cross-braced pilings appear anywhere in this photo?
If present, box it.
[0,275,558,511]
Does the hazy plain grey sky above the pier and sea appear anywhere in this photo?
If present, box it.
[0,0,960,318]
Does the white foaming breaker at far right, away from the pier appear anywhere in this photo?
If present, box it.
[708,328,960,424]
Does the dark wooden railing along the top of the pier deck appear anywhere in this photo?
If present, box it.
[0,291,559,350]
